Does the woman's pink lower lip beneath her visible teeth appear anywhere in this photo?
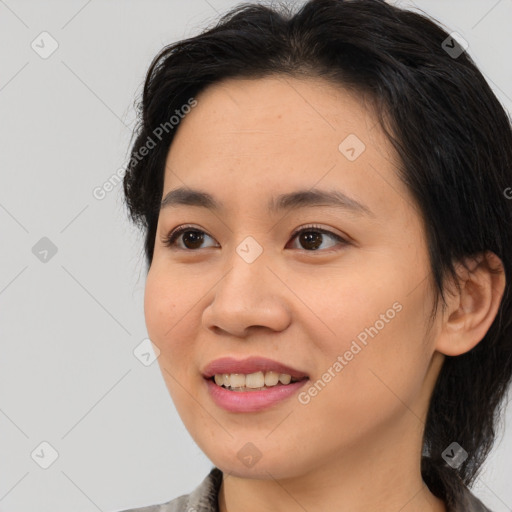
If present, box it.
[205,379,309,412]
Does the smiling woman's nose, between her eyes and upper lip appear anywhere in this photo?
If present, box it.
[203,249,293,338]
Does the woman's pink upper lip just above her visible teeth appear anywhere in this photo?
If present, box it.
[201,356,308,379]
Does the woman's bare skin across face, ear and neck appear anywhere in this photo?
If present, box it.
[145,76,505,512]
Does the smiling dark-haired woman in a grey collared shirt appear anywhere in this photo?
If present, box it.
[119,0,512,512]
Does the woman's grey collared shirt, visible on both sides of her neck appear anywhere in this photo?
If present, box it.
[119,467,492,512]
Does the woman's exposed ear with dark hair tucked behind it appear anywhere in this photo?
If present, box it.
[435,251,505,356]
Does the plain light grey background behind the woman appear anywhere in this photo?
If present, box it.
[0,0,512,512]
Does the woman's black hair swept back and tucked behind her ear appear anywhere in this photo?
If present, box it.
[124,0,512,505]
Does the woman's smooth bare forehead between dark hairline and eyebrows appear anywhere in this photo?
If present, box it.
[164,76,407,218]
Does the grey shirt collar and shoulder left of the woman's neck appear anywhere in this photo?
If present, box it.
[117,467,222,512]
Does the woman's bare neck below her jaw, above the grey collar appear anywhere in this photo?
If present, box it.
[218,415,447,512]
